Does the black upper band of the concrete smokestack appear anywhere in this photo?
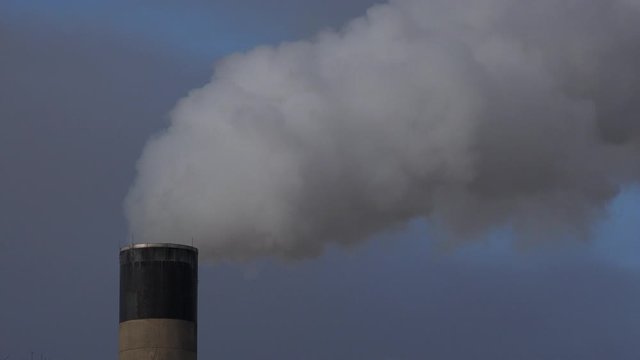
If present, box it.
[120,244,198,322]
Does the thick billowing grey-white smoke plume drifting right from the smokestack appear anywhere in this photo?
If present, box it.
[126,0,640,258]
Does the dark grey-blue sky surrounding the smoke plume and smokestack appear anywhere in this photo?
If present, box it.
[0,0,640,360]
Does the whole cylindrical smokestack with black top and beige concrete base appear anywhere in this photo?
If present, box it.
[119,244,198,360]
